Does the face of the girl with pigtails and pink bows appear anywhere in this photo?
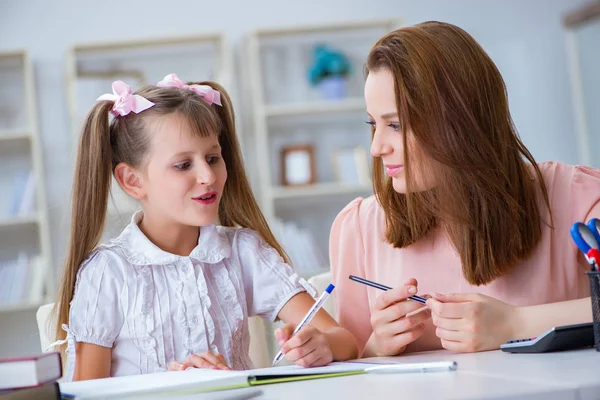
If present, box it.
[141,114,227,226]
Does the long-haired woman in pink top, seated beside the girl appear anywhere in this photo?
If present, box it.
[330,22,600,356]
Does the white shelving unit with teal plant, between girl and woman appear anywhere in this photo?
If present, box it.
[246,20,399,273]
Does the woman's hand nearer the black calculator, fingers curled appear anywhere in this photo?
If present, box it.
[427,293,518,353]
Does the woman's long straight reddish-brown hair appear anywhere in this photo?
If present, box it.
[365,22,551,285]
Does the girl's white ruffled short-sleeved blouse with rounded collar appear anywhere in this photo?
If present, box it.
[63,211,314,380]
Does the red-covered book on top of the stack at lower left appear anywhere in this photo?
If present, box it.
[0,352,62,390]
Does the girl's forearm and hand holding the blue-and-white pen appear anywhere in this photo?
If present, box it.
[275,292,358,367]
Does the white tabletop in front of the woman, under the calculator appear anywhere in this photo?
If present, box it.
[251,349,600,400]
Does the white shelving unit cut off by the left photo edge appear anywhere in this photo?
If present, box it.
[0,51,55,312]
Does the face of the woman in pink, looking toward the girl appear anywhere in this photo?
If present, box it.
[365,69,435,193]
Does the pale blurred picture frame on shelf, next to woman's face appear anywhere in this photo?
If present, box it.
[332,146,371,185]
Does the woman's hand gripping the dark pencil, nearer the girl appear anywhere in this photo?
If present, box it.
[364,278,431,356]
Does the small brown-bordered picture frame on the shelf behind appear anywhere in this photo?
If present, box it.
[281,144,317,186]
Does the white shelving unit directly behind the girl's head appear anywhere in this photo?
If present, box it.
[67,33,237,240]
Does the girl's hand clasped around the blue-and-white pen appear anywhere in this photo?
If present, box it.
[275,324,333,368]
